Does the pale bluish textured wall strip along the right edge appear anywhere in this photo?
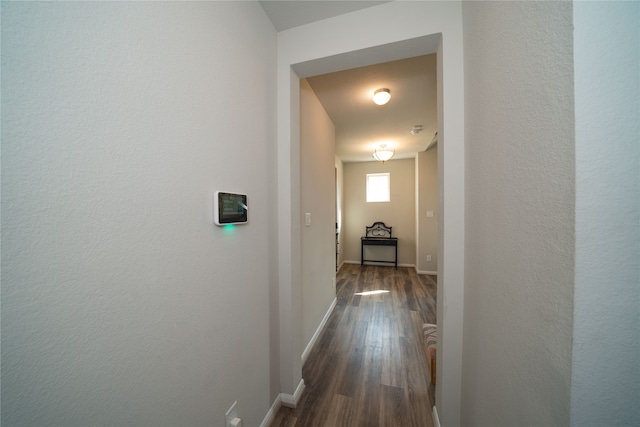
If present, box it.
[571,2,640,426]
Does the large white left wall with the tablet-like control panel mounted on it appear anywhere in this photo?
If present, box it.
[2,2,278,426]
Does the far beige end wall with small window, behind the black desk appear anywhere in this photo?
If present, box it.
[343,159,416,266]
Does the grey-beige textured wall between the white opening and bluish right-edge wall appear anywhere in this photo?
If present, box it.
[462,2,575,427]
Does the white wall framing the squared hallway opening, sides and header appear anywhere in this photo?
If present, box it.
[277,2,464,426]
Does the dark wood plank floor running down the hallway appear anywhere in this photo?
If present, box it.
[271,264,436,427]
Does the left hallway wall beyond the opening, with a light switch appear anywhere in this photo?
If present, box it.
[300,79,336,348]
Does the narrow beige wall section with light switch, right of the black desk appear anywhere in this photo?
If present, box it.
[416,146,438,274]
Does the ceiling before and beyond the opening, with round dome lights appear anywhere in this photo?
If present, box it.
[261,1,437,162]
